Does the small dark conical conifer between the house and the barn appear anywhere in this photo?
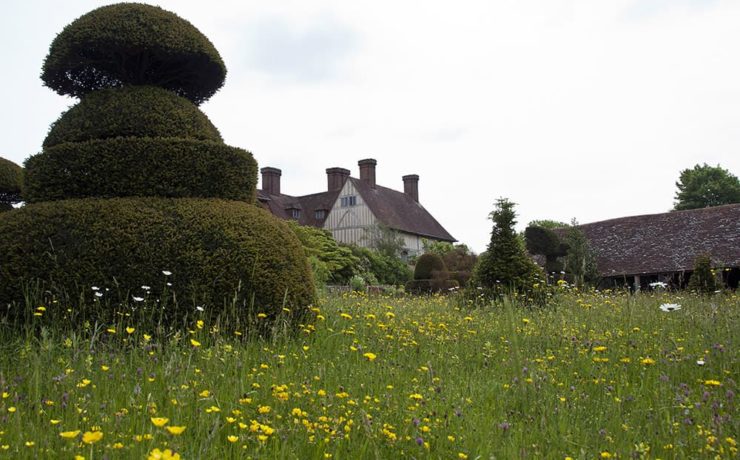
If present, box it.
[475,198,541,290]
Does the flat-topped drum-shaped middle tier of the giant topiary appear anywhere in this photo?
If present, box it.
[24,137,257,203]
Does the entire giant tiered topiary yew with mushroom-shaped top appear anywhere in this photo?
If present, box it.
[0,3,315,326]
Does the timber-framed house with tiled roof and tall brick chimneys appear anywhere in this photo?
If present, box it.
[258,158,457,256]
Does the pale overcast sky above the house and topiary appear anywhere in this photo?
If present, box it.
[0,0,740,252]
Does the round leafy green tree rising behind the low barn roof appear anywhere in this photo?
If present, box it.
[673,163,740,211]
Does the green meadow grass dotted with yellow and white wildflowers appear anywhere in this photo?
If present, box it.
[0,290,740,459]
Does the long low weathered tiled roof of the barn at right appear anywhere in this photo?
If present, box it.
[580,204,740,276]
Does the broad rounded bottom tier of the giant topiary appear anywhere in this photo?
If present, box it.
[0,198,315,316]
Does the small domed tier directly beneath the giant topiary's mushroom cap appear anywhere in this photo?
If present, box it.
[44,86,222,147]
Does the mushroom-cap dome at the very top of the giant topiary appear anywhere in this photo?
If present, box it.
[41,3,226,104]
